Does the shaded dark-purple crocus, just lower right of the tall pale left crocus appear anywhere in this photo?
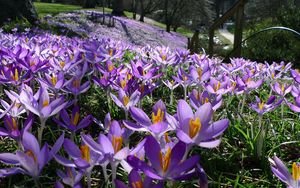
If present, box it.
[53,105,93,133]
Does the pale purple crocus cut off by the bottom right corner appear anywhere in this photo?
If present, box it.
[269,156,300,188]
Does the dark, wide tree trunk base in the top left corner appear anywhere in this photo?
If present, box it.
[0,0,38,25]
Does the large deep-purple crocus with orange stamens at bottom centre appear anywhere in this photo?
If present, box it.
[127,136,199,180]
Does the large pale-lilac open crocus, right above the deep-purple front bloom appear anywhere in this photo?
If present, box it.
[177,100,229,148]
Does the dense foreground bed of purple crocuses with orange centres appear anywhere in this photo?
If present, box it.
[0,29,300,187]
